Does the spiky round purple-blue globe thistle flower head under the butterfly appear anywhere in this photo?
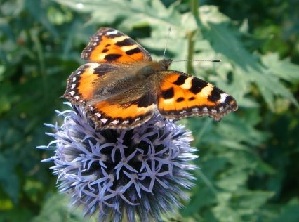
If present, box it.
[38,106,196,222]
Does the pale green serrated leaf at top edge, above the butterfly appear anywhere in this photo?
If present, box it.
[56,0,181,30]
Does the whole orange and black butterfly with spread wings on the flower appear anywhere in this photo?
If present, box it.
[64,27,238,129]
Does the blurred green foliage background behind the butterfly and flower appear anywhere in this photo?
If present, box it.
[0,0,299,222]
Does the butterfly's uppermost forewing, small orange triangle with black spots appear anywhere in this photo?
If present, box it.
[81,27,152,63]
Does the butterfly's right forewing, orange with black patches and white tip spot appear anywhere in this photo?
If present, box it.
[158,71,238,120]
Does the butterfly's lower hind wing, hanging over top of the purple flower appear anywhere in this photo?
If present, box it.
[86,87,157,129]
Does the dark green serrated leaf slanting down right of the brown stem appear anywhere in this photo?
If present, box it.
[200,7,299,110]
